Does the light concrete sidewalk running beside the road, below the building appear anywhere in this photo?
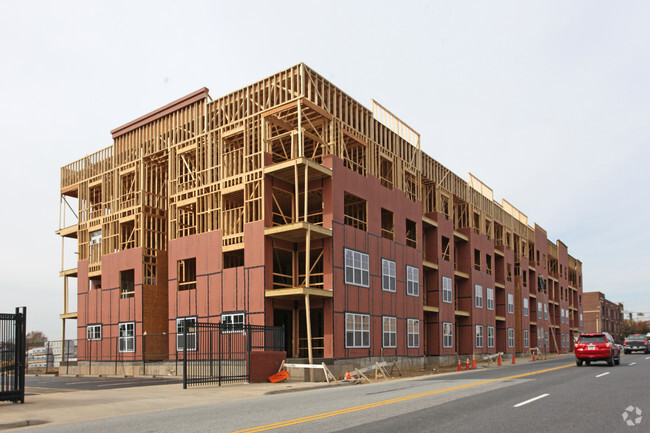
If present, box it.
[0,354,573,431]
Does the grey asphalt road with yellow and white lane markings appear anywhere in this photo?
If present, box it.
[26,354,650,433]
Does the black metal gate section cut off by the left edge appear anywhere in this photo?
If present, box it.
[0,307,27,403]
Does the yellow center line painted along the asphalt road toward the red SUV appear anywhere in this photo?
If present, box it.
[232,364,573,433]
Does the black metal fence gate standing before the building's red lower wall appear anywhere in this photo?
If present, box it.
[182,319,284,388]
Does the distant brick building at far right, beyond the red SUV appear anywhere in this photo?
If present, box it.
[582,292,625,343]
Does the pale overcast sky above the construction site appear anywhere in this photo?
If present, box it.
[0,0,650,339]
